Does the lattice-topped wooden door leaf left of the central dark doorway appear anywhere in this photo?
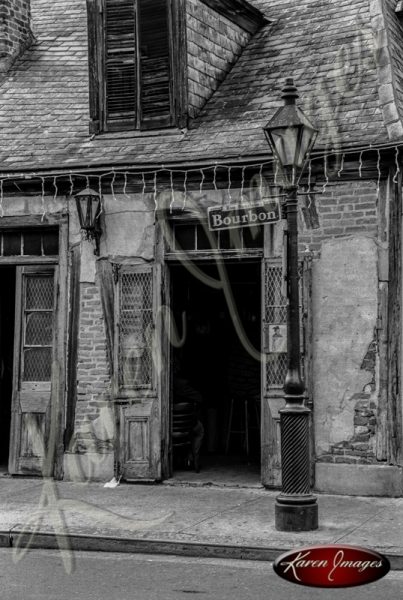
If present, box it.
[115,265,163,481]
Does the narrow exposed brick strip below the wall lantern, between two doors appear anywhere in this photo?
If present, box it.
[72,283,112,452]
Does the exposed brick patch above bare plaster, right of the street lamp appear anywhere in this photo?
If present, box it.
[299,181,378,252]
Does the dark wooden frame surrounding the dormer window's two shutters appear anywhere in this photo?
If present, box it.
[87,0,188,134]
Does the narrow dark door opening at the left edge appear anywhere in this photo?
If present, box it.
[0,267,15,471]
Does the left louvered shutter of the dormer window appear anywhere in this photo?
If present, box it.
[104,0,137,130]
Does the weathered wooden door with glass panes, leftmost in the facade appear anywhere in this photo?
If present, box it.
[9,265,56,475]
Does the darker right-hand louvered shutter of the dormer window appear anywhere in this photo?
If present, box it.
[138,0,173,129]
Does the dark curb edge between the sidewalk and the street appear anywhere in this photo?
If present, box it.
[0,529,403,571]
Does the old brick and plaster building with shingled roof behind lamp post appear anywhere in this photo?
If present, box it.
[0,0,403,496]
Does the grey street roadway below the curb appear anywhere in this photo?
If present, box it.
[0,548,403,600]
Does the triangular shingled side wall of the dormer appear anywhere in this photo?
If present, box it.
[186,0,250,118]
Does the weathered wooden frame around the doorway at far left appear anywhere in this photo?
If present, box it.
[0,213,69,479]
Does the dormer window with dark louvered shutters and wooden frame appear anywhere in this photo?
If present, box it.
[87,0,184,133]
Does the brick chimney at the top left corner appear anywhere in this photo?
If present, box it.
[0,0,33,74]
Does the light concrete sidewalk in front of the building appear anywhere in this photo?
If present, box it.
[0,477,403,570]
